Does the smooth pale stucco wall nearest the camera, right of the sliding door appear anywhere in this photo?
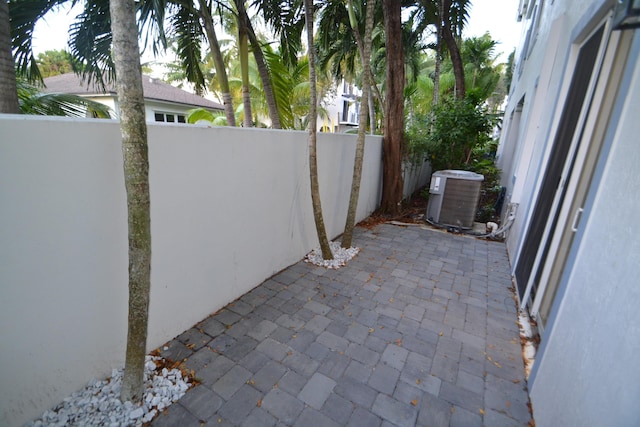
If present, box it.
[530,34,640,427]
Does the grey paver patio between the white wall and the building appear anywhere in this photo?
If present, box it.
[153,224,531,427]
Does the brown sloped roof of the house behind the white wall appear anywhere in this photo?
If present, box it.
[44,73,224,110]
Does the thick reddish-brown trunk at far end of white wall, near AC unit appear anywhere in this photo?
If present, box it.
[380,0,404,215]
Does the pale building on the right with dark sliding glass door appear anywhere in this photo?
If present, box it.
[498,0,640,427]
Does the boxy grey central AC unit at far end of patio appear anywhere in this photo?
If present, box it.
[427,170,484,229]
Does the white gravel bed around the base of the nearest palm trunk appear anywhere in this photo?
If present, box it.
[26,356,190,427]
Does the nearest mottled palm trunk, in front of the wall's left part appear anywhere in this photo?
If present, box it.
[109,0,151,403]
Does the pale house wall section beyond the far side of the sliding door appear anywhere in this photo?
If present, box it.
[497,0,605,263]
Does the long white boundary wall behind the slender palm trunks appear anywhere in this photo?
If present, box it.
[0,115,382,426]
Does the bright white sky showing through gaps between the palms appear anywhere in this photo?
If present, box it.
[33,0,521,62]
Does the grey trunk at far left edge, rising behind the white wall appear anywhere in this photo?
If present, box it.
[0,0,20,114]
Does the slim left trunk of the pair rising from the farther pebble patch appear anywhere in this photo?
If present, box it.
[304,0,333,260]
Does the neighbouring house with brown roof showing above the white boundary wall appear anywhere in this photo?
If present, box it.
[44,73,224,123]
